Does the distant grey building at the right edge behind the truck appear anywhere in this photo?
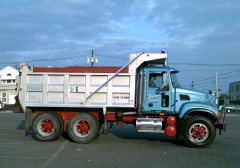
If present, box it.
[229,81,240,104]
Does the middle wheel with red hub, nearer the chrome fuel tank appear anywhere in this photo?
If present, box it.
[67,113,100,144]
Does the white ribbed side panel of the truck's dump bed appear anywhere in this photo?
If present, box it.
[19,66,135,107]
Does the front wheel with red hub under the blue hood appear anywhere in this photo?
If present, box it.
[182,116,216,148]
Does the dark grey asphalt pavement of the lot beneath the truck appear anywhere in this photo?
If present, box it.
[0,106,240,168]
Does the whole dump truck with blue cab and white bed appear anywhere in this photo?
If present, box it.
[14,52,226,148]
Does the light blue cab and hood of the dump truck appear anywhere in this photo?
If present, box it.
[142,66,218,117]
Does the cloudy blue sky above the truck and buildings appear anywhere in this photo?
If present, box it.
[0,0,240,94]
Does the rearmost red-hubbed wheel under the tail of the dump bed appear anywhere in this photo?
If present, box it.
[32,112,62,142]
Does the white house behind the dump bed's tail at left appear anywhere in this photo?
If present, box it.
[0,66,18,104]
